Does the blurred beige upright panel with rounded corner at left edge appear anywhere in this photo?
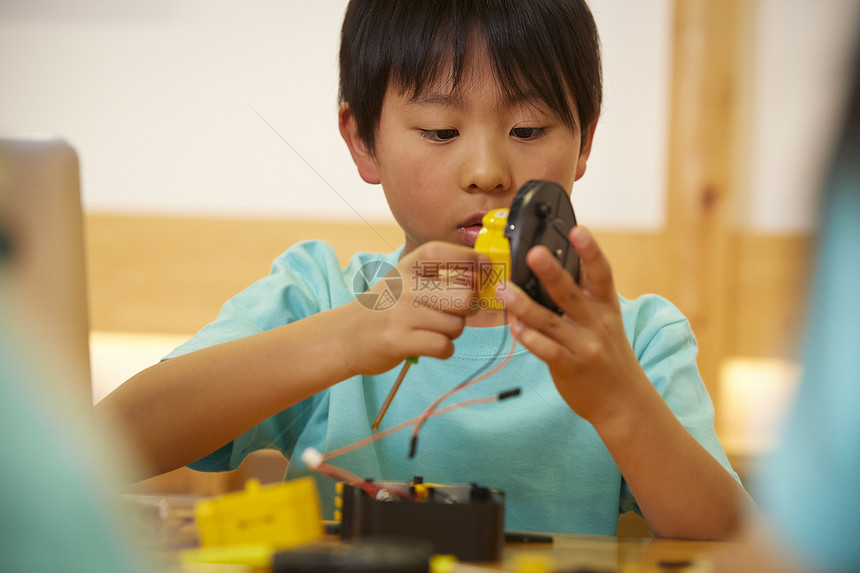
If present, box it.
[0,137,91,402]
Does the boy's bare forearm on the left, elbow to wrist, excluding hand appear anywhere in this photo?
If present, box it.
[96,307,362,477]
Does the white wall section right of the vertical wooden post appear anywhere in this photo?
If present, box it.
[742,0,860,233]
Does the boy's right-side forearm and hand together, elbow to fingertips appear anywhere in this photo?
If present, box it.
[496,227,752,539]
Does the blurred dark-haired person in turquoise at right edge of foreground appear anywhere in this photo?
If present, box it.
[756,45,860,571]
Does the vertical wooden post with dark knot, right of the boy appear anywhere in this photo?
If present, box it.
[666,0,749,395]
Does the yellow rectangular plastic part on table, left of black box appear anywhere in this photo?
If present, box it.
[194,477,324,549]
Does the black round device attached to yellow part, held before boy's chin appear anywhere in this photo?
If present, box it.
[505,181,579,314]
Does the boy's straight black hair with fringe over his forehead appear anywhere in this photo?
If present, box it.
[340,0,602,150]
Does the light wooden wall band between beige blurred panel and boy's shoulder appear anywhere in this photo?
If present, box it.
[86,215,402,333]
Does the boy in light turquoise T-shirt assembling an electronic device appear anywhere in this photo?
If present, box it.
[101,0,744,539]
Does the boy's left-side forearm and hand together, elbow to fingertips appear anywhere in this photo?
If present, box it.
[97,242,486,475]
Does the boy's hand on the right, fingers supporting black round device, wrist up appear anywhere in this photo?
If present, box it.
[496,226,647,425]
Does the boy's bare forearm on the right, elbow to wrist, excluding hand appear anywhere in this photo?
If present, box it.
[595,382,752,539]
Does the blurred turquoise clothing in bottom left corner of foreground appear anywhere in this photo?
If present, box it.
[0,312,151,573]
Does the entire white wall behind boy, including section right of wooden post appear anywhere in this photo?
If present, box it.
[0,0,858,230]
